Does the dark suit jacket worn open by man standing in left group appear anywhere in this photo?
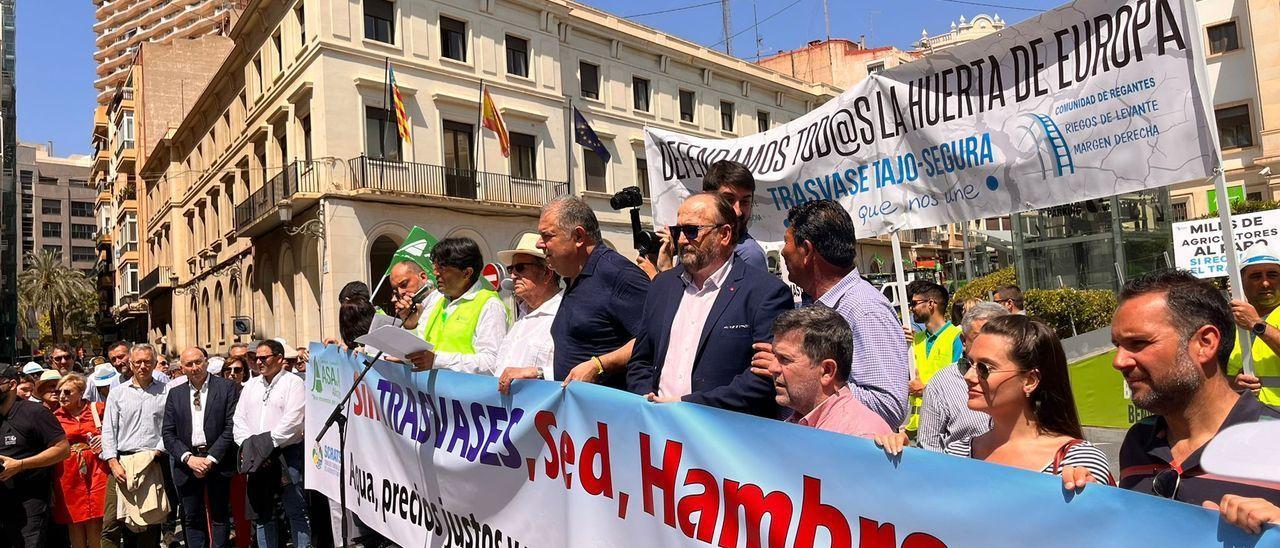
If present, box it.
[160,375,239,485]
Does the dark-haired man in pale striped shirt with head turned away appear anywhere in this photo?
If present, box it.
[751,200,910,428]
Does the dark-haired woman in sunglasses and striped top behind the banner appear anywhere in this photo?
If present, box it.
[877,315,1115,489]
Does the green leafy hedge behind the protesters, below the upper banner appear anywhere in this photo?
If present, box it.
[952,266,1116,338]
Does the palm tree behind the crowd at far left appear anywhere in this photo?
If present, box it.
[18,251,97,342]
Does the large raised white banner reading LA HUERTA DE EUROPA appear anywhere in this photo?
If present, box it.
[645,0,1217,242]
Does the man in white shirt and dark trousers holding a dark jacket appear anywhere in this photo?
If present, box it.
[233,341,311,548]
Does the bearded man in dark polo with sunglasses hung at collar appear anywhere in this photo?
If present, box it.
[1105,270,1280,533]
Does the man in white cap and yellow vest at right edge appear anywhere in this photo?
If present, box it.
[1226,243,1280,406]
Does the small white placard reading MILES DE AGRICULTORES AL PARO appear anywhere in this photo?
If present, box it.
[1174,209,1280,278]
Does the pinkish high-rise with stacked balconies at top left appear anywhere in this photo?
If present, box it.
[93,0,247,105]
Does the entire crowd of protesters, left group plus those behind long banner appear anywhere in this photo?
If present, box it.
[0,156,1280,547]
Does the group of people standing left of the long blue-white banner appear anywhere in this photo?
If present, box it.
[0,339,312,548]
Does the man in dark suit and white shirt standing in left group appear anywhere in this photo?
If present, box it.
[160,347,239,548]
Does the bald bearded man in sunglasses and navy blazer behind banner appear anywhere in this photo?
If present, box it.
[627,193,794,417]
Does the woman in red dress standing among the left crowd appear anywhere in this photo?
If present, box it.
[54,374,108,548]
